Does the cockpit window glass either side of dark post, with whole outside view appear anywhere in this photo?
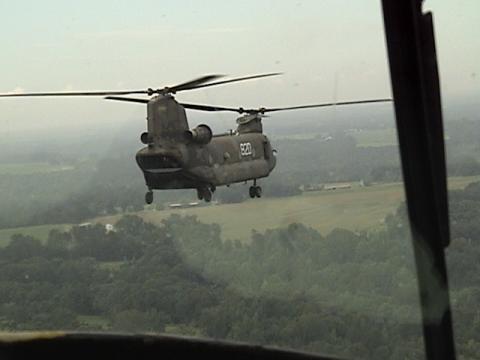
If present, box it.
[0,0,480,359]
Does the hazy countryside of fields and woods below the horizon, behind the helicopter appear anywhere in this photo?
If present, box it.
[0,109,480,359]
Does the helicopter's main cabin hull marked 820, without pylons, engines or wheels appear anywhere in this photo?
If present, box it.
[136,133,276,189]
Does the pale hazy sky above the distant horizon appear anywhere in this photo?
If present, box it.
[0,0,480,131]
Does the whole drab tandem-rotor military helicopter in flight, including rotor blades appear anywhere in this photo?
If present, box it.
[0,73,391,204]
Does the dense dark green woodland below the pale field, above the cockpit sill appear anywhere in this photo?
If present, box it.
[0,184,480,359]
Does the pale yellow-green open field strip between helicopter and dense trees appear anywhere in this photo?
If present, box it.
[95,176,480,241]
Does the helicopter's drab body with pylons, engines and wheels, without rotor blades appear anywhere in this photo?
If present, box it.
[136,95,276,204]
